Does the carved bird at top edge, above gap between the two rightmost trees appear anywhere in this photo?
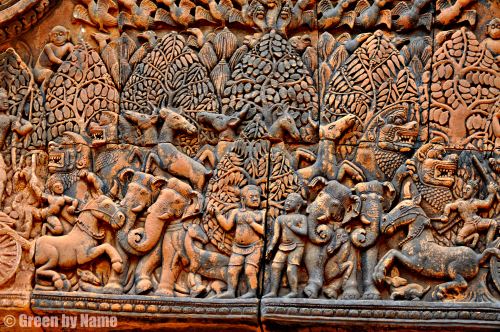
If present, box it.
[391,0,432,31]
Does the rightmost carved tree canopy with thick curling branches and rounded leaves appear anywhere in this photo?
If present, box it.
[423,28,500,149]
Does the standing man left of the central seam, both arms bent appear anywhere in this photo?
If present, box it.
[208,185,265,298]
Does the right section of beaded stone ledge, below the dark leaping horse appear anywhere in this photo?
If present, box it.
[261,298,500,331]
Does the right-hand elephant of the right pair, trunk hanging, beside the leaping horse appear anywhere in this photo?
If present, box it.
[350,180,396,300]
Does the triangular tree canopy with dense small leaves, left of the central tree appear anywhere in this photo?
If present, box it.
[120,33,219,155]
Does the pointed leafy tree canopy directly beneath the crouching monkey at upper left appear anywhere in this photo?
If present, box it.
[46,43,119,140]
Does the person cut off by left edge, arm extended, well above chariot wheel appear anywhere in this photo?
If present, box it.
[0,88,33,204]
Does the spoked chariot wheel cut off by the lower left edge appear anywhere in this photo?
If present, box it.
[0,228,22,286]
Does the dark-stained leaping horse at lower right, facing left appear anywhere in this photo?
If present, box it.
[373,195,500,300]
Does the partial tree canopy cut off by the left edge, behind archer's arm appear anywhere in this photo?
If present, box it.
[0,48,46,149]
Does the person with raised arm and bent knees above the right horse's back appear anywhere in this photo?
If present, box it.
[441,180,498,248]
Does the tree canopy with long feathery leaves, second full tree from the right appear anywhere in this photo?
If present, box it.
[321,31,418,157]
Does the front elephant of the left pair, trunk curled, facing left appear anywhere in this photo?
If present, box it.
[128,178,203,296]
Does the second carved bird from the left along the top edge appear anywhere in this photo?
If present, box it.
[118,0,157,30]
